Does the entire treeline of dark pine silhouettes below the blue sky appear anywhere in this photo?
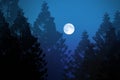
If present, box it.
[0,0,120,80]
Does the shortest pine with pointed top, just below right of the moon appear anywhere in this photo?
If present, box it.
[74,31,94,80]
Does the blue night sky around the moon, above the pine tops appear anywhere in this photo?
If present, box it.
[19,0,120,49]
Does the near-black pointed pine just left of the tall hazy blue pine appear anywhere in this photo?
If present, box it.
[11,11,47,80]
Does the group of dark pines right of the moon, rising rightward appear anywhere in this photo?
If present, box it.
[64,11,120,80]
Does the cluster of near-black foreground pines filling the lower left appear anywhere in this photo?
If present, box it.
[0,12,47,80]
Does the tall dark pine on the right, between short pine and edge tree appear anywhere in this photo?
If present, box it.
[90,14,119,80]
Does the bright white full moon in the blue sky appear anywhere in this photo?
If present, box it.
[63,23,75,35]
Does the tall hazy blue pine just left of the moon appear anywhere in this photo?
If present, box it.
[33,2,64,80]
